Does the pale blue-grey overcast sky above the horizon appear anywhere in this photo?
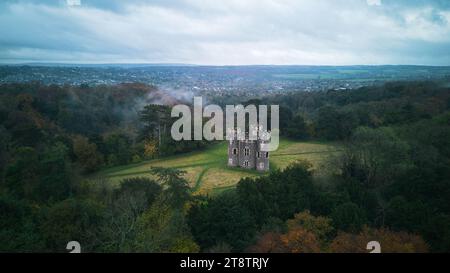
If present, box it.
[0,0,450,65]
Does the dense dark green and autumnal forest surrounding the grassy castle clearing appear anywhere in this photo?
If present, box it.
[0,82,450,253]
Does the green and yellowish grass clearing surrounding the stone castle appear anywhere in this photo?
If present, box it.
[98,140,337,194]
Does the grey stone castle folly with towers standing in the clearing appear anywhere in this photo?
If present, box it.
[228,129,269,172]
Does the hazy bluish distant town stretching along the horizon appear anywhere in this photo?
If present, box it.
[0,64,450,97]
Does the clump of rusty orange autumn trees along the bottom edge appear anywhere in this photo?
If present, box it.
[248,211,428,253]
